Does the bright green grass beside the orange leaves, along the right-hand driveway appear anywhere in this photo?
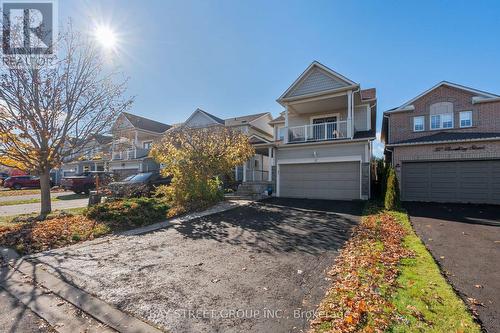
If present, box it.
[389,212,481,333]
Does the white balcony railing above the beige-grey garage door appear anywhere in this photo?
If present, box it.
[287,120,348,143]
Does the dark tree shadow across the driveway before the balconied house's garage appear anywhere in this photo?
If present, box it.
[174,203,361,254]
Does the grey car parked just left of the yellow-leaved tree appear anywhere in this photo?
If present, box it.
[108,172,171,197]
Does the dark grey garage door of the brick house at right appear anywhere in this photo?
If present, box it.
[402,160,500,204]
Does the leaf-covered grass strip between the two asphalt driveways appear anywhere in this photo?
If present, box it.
[311,206,480,333]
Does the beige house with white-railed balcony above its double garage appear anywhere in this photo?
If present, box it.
[242,61,377,200]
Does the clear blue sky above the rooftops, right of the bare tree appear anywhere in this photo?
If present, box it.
[58,0,500,154]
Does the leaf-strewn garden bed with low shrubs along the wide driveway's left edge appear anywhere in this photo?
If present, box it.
[0,198,168,254]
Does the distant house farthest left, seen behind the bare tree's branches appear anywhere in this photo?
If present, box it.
[59,135,113,178]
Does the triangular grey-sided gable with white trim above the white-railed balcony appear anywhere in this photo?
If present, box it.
[278,61,358,102]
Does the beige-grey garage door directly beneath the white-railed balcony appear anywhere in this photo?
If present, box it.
[279,162,360,200]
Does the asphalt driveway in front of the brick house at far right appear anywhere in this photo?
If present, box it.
[405,203,500,332]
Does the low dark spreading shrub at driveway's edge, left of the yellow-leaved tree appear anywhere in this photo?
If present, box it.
[85,198,169,230]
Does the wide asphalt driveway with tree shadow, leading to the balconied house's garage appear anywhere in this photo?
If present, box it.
[31,199,363,332]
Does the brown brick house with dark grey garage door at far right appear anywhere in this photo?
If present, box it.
[381,81,500,204]
